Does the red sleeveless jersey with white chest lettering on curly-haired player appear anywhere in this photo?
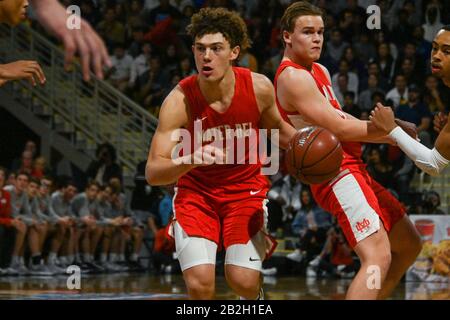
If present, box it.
[177,67,267,191]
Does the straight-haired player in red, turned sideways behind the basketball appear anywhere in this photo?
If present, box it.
[275,2,421,299]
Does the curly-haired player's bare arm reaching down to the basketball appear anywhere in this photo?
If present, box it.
[252,73,297,149]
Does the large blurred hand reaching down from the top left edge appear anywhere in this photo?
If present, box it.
[32,0,111,81]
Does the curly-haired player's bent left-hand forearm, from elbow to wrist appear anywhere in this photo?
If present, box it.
[145,157,194,186]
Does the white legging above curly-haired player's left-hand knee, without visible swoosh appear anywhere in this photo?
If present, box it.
[173,221,217,271]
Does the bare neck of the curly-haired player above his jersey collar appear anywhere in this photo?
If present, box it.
[198,68,236,101]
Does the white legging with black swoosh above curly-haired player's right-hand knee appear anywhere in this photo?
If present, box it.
[225,231,266,271]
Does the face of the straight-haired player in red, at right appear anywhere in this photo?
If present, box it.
[283,16,324,62]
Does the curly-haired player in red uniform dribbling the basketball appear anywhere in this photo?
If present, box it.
[146,8,296,299]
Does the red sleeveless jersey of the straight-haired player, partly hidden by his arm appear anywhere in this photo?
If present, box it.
[275,61,365,182]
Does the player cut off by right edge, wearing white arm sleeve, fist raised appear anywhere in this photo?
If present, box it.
[371,25,450,176]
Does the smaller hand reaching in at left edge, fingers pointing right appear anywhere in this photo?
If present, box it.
[0,60,46,86]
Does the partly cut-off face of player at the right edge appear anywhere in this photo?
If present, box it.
[431,30,450,82]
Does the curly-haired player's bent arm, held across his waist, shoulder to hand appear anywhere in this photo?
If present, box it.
[145,86,225,185]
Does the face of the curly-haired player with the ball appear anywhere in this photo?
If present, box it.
[192,33,240,82]
